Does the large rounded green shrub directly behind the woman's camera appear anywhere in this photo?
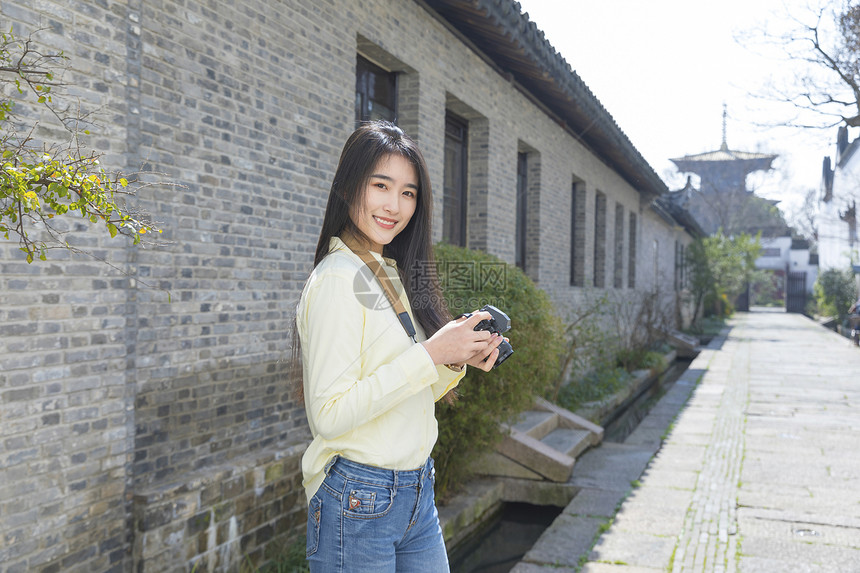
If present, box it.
[433,244,563,499]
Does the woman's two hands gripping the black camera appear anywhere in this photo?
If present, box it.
[421,312,504,372]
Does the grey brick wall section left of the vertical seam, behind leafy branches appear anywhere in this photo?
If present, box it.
[0,1,134,572]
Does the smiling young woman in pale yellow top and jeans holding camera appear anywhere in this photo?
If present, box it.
[296,118,503,573]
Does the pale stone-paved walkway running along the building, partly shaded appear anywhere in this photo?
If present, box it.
[513,309,860,573]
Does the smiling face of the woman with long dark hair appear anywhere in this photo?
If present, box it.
[350,154,418,254]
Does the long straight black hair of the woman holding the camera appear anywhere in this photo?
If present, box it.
[292,121,451,393]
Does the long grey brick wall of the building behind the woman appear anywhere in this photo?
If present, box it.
[0,0,696,573]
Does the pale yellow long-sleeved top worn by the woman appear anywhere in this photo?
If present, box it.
[296,237,465,500]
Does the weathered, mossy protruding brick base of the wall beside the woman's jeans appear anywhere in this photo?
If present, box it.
[132,447,305,573]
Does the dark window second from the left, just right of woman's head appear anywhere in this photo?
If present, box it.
[442,113,468,247]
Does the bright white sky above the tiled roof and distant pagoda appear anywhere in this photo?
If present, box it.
[519,0,853,223]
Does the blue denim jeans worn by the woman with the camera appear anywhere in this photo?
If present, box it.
[307,457,449,573]
